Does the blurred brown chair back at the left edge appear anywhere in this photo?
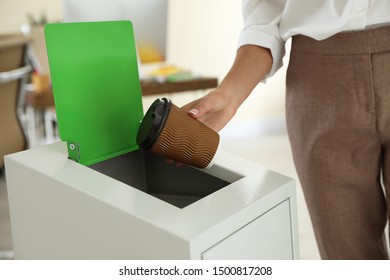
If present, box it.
[0,34,32,168]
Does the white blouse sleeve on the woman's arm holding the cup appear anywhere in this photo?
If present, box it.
[238,0,287,77]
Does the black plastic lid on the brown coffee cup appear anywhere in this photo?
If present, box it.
[137,98,171,150]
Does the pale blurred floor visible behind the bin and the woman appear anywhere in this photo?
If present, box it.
[0,126,319,260]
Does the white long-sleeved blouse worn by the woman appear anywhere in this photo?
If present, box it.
[238,0,390,77]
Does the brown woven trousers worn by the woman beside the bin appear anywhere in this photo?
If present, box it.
[286,27,390,259]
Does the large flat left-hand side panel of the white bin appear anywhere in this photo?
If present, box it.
[6,157,189,259]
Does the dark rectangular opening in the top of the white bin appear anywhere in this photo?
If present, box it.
[89,150,242,208]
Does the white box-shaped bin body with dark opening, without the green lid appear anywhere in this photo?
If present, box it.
[5,142,299,259]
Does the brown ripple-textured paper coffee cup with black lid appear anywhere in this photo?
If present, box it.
[137,98,220,168]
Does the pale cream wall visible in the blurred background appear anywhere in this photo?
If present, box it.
[0,0,285,138]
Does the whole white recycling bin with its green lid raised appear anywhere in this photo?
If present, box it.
[5,21,299,260]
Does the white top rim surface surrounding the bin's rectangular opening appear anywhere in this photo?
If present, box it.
[6,142,295,240]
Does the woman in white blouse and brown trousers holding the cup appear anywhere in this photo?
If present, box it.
[183,0,390,259]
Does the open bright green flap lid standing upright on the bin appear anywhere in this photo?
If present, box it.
[45,21,143,165]
